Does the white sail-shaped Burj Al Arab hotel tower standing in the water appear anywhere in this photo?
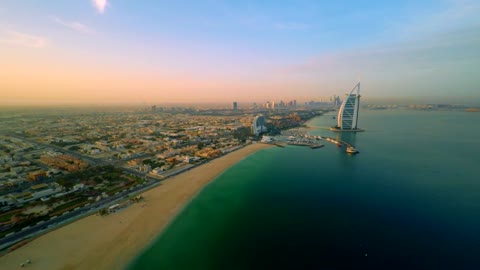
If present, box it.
[330,82,363,132]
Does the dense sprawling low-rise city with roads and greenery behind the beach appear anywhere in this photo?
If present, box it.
[0,102,332,251]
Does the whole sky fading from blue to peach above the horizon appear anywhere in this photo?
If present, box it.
[0,0,480,105]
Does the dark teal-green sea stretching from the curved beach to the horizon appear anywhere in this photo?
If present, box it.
[128,110,480,270]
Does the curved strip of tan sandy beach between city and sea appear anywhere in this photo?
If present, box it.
[0,144,269,270]
